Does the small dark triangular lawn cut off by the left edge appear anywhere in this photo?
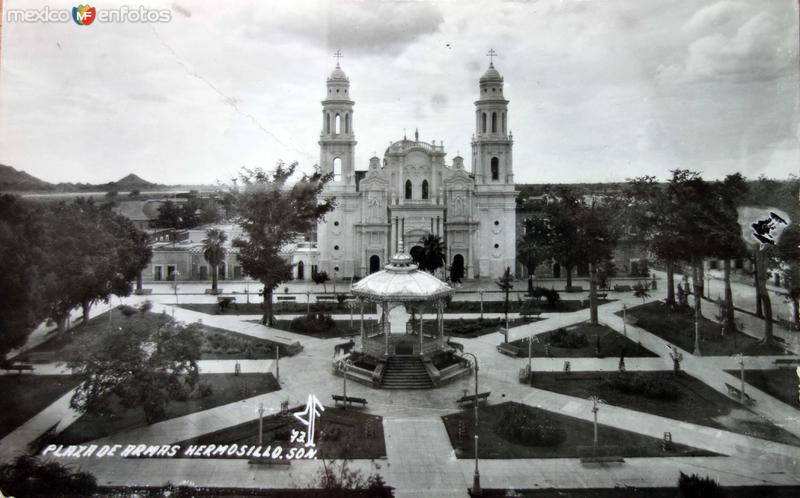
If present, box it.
[0,375,78,438]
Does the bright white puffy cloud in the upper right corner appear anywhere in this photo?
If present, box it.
[657,2,797,83]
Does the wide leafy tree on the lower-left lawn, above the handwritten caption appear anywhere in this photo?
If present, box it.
[69,315,200,424]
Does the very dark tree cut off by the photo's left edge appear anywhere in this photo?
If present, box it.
[0,194,48,358]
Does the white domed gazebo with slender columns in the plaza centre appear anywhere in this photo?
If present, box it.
[351,242,453,360]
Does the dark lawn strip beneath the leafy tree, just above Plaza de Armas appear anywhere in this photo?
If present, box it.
[53,374,280,444]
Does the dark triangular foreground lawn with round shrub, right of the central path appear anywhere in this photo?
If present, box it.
[442,401,713,459]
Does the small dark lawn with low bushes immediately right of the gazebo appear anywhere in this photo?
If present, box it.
[510,322,657,358]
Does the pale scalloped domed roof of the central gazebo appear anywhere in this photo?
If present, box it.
[351,243,453,302]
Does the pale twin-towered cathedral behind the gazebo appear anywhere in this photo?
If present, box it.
[292,52,517,280]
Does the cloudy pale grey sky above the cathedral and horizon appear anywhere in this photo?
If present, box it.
[0,0,800,184]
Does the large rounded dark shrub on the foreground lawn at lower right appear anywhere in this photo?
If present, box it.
[494,405,567,446]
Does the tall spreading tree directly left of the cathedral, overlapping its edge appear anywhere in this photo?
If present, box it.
[231,163,334,325]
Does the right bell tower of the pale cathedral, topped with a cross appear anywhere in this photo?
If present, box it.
[472,49,514,190]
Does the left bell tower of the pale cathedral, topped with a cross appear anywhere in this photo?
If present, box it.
[319,50,356,185]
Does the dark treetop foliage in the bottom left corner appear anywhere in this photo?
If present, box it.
[0,455,97,497]
